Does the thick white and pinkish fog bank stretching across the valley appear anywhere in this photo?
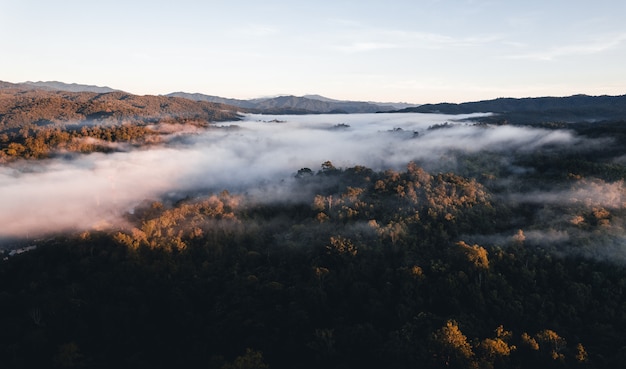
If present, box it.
[0,114,616,244]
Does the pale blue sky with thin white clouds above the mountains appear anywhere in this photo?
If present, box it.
[0,0,626,104]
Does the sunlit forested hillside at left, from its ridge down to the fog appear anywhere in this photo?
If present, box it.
[0,83,238,163]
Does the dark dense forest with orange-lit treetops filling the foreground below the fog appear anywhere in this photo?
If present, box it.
[0,85,626,369]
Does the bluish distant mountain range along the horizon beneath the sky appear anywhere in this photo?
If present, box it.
[0,81,626,124]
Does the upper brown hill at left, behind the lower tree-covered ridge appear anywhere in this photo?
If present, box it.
[0,82,238,130]
